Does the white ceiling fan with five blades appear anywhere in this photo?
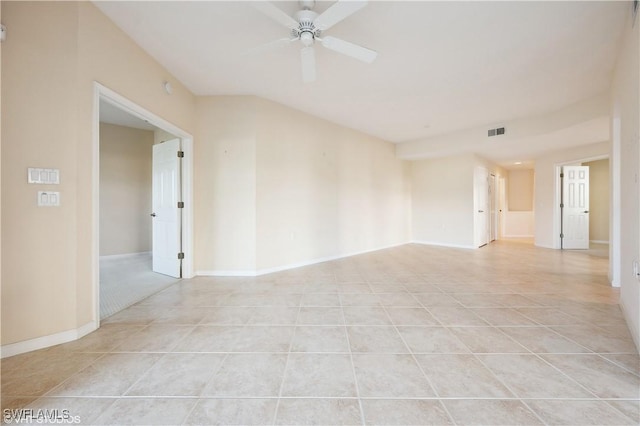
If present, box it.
[255,0,378,83]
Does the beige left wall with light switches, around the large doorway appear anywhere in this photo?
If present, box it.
[1,2,195,345]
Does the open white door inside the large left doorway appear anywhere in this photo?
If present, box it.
[151,139,182,278]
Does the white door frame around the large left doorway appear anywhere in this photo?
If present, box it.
[91,81,194,328]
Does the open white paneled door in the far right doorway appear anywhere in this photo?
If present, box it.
[562,166,589,249]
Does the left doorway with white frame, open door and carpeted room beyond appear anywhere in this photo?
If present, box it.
[93,83,193,324]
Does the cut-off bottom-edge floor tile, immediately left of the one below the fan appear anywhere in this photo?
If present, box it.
[185,398,278,426]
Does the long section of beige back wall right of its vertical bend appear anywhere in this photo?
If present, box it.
[256,100,411,270]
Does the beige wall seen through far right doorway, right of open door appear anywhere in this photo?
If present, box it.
[582,158,610,242]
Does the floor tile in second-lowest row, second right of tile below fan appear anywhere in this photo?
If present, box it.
[416,355,514,398]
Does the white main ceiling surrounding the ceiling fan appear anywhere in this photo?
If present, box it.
[95,1,630,166]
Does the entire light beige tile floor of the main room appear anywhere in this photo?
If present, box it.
[2,242,640,425]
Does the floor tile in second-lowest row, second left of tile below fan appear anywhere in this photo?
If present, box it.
[127,353,226,397]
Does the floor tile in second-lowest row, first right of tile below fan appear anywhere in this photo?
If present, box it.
[353,354,435,398]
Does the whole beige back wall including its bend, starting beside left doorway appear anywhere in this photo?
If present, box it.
[195,96,410,274]
